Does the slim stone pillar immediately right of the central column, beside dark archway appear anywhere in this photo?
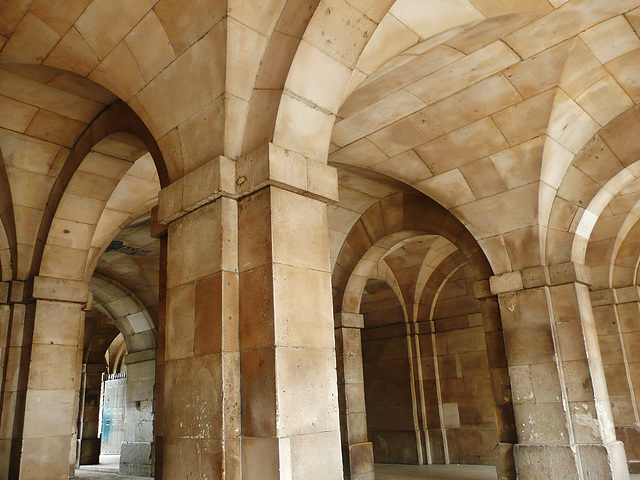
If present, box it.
[335,313,375,480]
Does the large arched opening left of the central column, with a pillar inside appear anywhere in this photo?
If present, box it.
[0,65,168,478]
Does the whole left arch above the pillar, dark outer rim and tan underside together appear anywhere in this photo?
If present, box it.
[32,95,169,281]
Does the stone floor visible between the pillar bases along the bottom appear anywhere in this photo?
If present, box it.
[76,462,640,480]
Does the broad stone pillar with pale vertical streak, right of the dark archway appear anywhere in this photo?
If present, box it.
[490,262,629,480]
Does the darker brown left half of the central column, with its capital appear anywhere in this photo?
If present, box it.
[155,157,241,480]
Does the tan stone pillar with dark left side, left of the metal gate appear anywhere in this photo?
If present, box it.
[2,277,89,480]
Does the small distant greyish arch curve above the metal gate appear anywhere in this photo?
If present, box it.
[90,273,157,353]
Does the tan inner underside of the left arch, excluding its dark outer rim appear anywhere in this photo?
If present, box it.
[39,133,160,281]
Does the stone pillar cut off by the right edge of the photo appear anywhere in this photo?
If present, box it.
[591,286,640,473]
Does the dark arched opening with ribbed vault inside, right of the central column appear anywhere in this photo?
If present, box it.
[334,188,515,478]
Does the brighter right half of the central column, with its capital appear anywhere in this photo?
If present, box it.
[236,144,343,480]
